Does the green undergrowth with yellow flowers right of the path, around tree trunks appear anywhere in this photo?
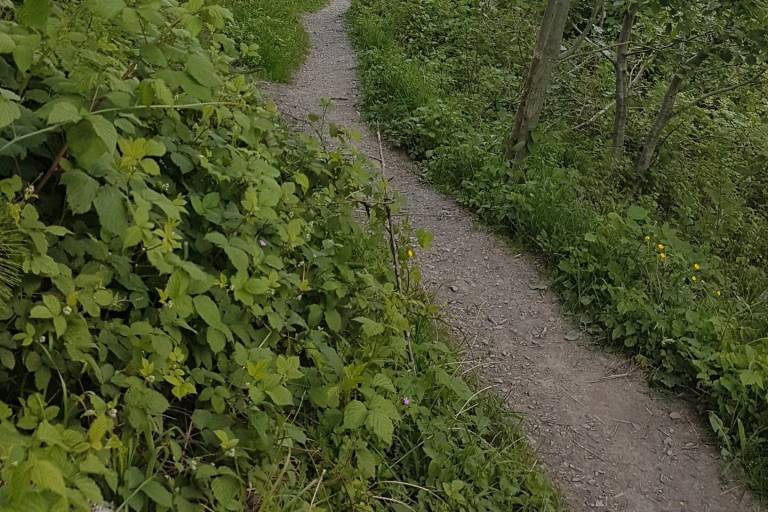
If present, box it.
[350,0,768,493]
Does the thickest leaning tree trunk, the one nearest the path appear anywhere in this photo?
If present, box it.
[505,0,570,161]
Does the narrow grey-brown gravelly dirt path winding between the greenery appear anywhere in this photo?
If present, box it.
[267,0,753,512]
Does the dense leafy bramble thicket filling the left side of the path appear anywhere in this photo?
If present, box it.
[0,0,558,512]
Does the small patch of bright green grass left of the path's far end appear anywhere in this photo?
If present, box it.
[223,0,327,82]
